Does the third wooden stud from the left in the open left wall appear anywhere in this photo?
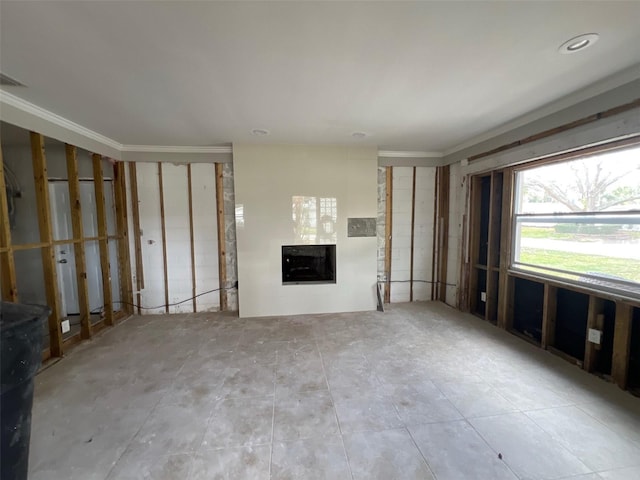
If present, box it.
[65,143,92,339]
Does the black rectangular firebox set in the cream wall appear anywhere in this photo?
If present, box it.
[282,245,336,285]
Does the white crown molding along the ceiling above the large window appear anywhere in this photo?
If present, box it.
[444,64,640,157]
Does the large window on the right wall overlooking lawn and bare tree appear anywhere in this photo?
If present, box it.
[512,145,640,294]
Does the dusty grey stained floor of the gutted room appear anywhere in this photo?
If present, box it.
[29,303,640,480]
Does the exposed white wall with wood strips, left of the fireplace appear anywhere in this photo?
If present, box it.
[129,163,220,314]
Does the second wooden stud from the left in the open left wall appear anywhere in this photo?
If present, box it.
[30,132,63,357]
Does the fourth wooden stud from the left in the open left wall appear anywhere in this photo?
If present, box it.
[91,153,113,325]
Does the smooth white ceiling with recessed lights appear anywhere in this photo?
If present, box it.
[0,0,640,152]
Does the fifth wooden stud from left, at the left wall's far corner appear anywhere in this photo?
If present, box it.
[113,162,133,316]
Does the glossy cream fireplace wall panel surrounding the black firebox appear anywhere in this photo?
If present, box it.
[234,145,377,317]
